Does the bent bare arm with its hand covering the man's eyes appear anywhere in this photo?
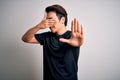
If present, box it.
[22,16,54,43]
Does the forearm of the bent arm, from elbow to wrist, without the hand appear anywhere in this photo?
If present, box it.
[22,25,40,42]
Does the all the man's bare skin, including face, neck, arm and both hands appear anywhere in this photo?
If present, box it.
[22,11,84,47]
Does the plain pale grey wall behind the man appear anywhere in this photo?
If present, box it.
[0,0,120,80]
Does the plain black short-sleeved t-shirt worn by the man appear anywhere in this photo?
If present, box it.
[35,31,80,80]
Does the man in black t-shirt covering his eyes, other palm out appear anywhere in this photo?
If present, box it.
[22,4,84,80]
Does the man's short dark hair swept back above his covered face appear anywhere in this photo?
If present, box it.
[45,4,68,26]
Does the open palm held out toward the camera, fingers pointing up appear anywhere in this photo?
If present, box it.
[59,18,84,47]
